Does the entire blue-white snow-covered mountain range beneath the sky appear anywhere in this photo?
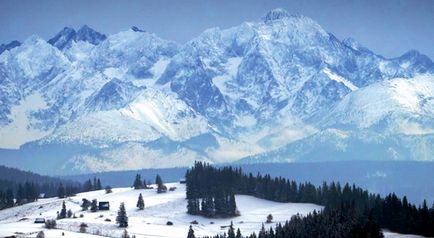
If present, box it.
[0,9,434,173]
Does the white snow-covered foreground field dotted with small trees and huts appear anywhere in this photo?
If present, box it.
[0,183,420,238]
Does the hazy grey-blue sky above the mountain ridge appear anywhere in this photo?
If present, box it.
[0,0,434,59]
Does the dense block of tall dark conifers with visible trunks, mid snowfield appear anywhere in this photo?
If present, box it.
[185,163,239,217]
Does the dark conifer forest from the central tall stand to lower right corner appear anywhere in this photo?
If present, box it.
[186,162,434,238]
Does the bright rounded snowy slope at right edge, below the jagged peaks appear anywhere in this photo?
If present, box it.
[330,75,434,131]
